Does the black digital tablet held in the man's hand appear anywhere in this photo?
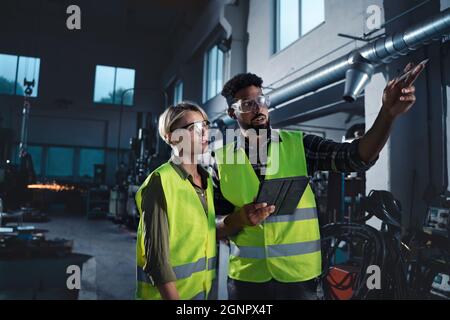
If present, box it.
[255,176,309,214]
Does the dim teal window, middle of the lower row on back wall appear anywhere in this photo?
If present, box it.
[46,147,75,177]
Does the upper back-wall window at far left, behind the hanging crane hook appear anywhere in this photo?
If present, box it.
[0,54,40,97]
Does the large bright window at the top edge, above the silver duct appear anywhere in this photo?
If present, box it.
[275,0,325,52]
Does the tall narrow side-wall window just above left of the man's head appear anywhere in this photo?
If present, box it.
[203,46,225,102]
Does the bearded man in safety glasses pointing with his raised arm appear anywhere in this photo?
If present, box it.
[215,64,424,300]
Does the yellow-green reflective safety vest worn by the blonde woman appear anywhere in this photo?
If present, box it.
[136,163,216,300]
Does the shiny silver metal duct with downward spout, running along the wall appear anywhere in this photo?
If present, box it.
[270,9,450,106]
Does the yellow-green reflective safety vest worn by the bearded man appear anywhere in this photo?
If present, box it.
[216,130,321,283]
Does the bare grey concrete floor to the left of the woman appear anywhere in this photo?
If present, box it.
[23,216,136,300]
